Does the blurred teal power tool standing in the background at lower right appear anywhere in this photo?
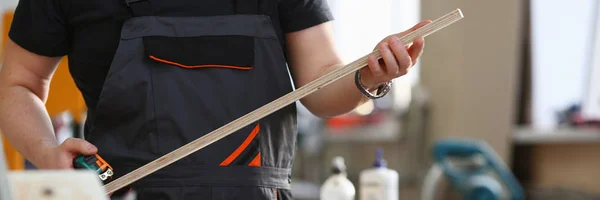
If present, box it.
[422,139,525,200]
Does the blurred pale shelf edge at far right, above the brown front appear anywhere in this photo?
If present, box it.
[513,127,600,144]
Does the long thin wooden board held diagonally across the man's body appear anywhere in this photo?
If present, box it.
[104,9,463,194]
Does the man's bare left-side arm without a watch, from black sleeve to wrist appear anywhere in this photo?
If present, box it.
[0,40,95,168]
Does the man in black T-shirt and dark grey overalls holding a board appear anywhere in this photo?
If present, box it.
[0,0,429,199]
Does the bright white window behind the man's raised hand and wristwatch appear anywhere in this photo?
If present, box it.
[327,0,421,109]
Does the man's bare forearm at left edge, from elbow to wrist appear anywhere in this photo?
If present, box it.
[0,85,58,166]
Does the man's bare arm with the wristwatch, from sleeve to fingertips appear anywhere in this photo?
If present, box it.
[287,21,430,118]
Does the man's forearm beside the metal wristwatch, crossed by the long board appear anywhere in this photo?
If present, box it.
[302,64,369,118]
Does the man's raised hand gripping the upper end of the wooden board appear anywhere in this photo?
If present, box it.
[360,20,431,89]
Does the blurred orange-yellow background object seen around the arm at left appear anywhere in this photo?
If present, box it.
[2,11,86,170]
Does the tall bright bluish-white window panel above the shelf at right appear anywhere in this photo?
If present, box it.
[531,0,598,129]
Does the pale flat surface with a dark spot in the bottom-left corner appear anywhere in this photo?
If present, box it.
[8,170,108,200]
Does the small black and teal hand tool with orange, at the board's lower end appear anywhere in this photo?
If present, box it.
[73,154,114,182]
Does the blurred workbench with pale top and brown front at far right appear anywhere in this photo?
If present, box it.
[512,127,600,199]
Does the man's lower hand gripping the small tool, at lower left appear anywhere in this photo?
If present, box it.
[37,138,98,169]
